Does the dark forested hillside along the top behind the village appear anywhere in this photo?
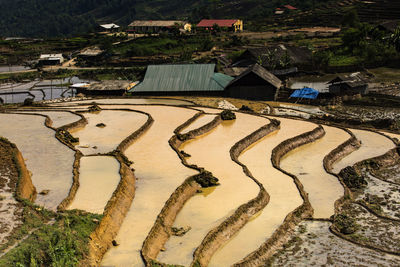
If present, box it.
[0,0,330,37]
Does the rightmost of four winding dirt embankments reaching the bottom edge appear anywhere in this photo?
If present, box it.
[234,126,325,267]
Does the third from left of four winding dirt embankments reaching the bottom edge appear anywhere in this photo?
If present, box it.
[191,120,280,266]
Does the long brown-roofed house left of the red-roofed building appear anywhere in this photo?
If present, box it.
[128,20,192,33]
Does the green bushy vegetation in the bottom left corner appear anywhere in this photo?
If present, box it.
[0,201,101,266]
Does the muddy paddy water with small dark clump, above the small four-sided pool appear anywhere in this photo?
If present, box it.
[71,110,147,155]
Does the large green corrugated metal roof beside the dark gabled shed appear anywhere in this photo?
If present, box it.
[131,64,233,92]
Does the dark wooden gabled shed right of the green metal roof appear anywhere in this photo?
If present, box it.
[225,64,282,100]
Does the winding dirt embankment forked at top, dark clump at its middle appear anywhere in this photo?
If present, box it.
[141,112,222,266]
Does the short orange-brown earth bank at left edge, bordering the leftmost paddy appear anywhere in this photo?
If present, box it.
[0,137,37,202]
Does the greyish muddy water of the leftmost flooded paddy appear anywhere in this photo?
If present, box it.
[0,114,75,209]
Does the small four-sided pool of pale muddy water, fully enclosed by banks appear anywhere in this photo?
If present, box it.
[68,156,121,214]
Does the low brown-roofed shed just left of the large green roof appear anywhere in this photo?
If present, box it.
[75,80,136,96]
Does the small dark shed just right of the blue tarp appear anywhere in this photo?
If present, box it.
[328,75,368,96]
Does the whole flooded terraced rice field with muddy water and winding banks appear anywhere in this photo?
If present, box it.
[0,98,400,267]
